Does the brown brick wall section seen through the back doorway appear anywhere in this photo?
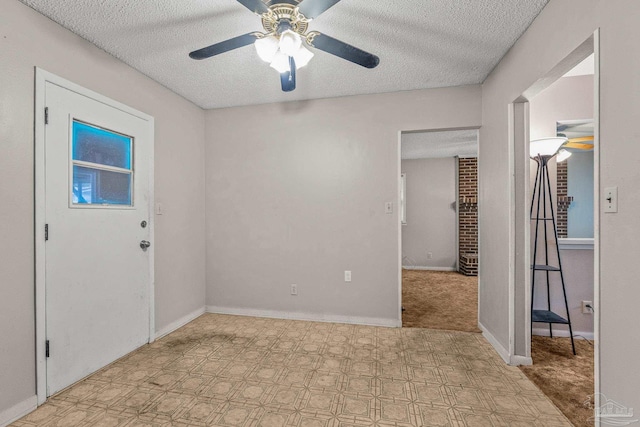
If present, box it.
[458,158,478,276]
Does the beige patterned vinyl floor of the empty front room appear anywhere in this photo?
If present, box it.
[13,314,570,427]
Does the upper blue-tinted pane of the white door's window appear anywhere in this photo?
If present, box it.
[72,120,131,169]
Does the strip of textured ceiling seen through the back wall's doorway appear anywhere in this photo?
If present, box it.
[400,130,478,160]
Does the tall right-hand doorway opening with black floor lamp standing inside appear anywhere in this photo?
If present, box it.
[512,33,599,426]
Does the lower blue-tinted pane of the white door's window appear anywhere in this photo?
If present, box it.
[73,165,131,206]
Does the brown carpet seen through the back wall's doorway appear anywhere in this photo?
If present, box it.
[402,270,480,332]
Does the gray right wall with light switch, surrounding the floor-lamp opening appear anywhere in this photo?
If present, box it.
[479,0,640,414]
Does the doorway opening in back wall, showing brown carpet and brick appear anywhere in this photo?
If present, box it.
[400,129,480,332]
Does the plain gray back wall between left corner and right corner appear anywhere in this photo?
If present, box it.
[206,86,481,325]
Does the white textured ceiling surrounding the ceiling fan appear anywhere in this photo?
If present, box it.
[20,0,548,108]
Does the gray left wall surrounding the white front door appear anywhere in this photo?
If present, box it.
[0,0,205,413]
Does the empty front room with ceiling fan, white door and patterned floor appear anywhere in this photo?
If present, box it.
[0,0,640,427]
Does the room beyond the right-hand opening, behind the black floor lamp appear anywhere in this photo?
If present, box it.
[522,55,594,425]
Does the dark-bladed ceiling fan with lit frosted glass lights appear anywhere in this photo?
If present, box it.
[189,0,380,92]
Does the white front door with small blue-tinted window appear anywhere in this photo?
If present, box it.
[44,82,153,396]
